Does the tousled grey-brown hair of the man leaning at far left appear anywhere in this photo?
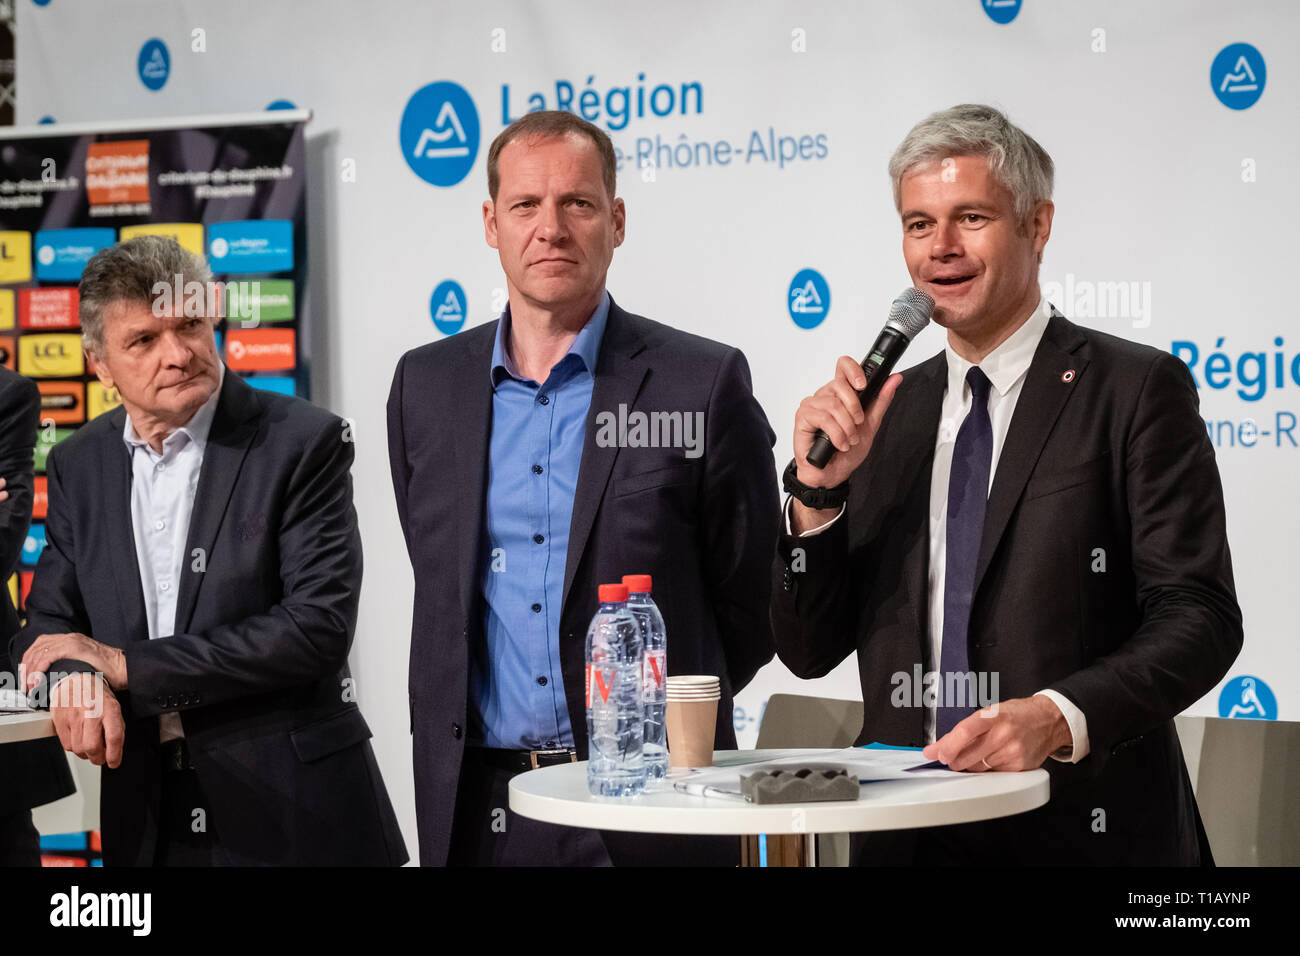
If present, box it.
[78,235,216,355]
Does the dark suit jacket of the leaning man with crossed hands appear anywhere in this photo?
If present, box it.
[12,371,407,865]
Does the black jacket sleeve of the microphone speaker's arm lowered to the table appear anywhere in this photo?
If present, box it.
[1050,355,1243,760]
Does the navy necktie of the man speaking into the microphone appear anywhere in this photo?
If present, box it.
[935,365,993,740]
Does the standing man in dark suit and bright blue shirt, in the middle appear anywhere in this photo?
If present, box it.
[389,112,777,865]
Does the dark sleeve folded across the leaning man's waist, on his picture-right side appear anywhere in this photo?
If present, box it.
[125,419,361,714]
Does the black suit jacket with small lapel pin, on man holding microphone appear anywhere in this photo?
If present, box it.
[772,315,1242,864]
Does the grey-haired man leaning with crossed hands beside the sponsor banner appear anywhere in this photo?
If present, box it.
[12,237,407,865]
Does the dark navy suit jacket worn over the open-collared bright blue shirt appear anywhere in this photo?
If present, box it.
[389,300,777,865]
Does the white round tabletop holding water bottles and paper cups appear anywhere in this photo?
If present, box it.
[510,750,1050,868]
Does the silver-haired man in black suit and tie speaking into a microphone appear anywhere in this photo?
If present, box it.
[772,105,1242,865]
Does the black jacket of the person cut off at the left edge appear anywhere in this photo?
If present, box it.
[0,368,77,817]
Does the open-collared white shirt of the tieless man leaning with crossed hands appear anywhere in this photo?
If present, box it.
[122,365,225,743]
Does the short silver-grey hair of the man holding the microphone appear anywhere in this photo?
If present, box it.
[889,103,1054,224]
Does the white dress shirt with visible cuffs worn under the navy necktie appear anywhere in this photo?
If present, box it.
[785,295,1089,763]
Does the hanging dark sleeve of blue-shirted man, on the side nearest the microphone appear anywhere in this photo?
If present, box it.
[701,349,777,693]
